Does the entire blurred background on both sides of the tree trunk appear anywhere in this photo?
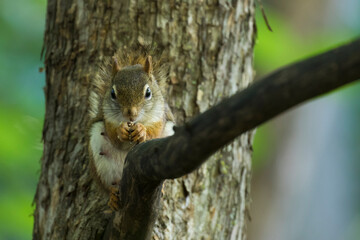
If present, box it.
[0,0,360,240]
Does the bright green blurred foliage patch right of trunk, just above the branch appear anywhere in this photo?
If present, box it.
[255,7,360,74]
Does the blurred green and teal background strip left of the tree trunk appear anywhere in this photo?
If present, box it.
[0,0,46,240]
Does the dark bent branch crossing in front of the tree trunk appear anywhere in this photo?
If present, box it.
[111,39,360,239]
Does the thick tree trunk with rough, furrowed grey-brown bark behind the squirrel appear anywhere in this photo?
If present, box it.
[33,0,256,239]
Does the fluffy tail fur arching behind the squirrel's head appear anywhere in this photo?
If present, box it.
[89,43,169,119]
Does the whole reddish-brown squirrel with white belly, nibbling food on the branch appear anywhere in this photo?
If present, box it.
[88,47,175,210]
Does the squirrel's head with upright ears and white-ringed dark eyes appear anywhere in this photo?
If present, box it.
[103,56,164,122]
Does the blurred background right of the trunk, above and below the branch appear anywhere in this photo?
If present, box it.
[248,0,360,240]
